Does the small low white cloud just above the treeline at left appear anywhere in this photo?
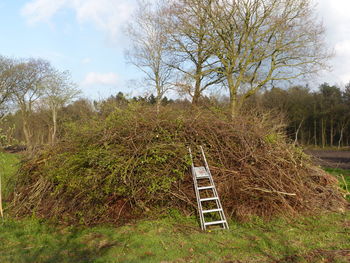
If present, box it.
[81,72,119,87]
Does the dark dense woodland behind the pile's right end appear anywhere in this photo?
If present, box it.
[251,83,350,147]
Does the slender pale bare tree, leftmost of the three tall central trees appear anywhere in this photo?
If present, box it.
[126,2,173,111]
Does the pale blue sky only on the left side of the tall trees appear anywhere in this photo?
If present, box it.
[0,0,141,99]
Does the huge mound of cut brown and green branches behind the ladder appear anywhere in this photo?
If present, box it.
[11,105,347,225]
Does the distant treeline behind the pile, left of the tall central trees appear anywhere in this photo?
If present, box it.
[0,92,175,147]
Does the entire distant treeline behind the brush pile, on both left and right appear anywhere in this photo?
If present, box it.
[0,83,350,147]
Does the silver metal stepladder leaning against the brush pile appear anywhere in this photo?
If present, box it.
[188,146,229,230]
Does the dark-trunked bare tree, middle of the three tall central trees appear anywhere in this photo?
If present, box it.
[164,0,220,104]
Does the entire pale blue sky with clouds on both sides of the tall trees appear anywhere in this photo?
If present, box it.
[0,0,350,99]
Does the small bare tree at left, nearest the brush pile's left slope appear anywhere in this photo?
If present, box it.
[43,71,80,144]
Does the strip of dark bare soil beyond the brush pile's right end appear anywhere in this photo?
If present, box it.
[306,150,350,170]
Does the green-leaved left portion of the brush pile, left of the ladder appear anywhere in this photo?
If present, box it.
[12,103,189,223]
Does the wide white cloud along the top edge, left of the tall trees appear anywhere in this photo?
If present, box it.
[21,0,134,40]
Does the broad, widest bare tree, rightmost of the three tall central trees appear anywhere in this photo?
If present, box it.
[206,0,330,116]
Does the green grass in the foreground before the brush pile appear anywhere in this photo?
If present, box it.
[0,155,350,263]
